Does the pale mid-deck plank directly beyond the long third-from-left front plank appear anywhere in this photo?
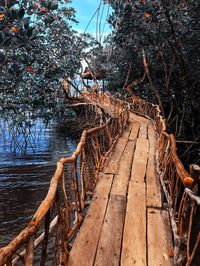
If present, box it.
[131,139,149,183]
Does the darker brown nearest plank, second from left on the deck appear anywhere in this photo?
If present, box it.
[94,195,126,266]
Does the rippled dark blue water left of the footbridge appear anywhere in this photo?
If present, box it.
[0,120,77,247]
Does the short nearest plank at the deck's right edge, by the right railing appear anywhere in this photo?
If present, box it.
[147,208,173,266]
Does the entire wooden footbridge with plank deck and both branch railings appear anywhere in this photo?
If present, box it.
[0,93,200,266]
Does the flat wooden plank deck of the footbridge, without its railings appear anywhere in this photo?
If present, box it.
[67,114,173,266]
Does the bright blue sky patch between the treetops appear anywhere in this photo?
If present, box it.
[71,0,111,40]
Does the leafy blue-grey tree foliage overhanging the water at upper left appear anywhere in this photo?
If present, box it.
[0,0,92,124]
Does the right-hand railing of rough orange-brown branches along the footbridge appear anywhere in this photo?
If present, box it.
[130,98,200,266]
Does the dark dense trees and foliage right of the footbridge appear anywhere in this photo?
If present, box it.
[91,0,200,166]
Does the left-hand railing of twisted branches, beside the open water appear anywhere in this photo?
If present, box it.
[0,95,129,265]
